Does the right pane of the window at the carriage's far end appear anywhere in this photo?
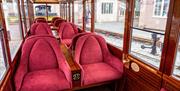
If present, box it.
[47,4,60,21]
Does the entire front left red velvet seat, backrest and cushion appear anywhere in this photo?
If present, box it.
[14,35,72,91]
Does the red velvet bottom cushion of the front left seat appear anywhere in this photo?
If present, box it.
[21,69,70,91]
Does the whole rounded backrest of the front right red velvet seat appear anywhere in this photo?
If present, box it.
[75,34,107,65]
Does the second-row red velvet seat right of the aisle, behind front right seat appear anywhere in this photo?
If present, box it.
[58,22,78,46]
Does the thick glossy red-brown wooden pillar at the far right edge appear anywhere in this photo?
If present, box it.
[163,0,180,75]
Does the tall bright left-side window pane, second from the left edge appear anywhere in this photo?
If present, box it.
[2,0,22,59]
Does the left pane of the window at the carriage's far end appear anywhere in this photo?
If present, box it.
[33,4,46,19]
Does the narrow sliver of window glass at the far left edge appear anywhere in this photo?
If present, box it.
[0,27,8,83]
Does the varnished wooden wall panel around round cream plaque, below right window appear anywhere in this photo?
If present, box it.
[124,57,162,91]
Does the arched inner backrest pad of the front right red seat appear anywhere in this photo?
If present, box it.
[80,36,103,64]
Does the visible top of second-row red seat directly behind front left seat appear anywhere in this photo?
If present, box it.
[30,23,53,35]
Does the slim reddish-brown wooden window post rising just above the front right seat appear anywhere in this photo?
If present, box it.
[91,0,95,33]
